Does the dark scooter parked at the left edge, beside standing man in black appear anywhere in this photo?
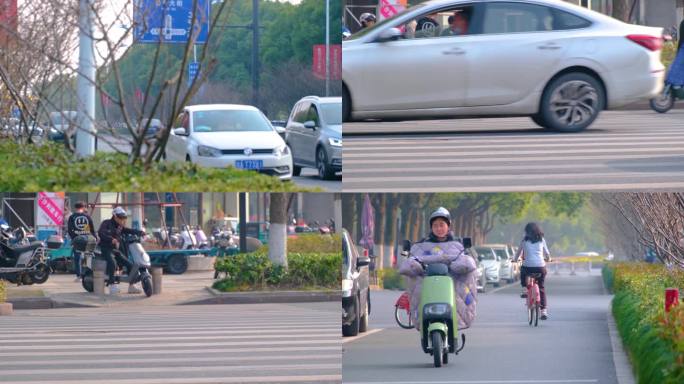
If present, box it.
[0,224,50,285]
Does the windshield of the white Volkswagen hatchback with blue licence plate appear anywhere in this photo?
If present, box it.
[193,110,273,133]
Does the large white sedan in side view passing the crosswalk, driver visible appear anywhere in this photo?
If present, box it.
[342,0,665,132]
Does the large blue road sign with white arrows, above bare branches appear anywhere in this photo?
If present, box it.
[133,0,211,44]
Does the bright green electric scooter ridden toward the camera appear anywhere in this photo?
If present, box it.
[404,238,472,367]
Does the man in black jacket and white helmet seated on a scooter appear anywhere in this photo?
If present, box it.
[97,207,145,294]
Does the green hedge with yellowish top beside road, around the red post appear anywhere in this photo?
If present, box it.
[603,263,684,384]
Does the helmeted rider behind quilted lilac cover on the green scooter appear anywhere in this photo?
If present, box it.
[399,207,477,330]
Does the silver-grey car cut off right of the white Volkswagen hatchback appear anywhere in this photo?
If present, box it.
[285,96,342,179]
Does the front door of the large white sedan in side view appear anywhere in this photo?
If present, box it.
[345,4,479,111]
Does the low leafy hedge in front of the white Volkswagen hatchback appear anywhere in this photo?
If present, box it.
[0,140,310,192]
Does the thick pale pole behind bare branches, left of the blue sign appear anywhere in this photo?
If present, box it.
[76,0,96,157]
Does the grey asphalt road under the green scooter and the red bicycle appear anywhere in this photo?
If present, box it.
[342,272,617,384]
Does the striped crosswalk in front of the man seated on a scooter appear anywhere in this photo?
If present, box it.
[0,303,342,384]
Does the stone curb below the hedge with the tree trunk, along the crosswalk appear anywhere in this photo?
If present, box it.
[179,287,342,305]
